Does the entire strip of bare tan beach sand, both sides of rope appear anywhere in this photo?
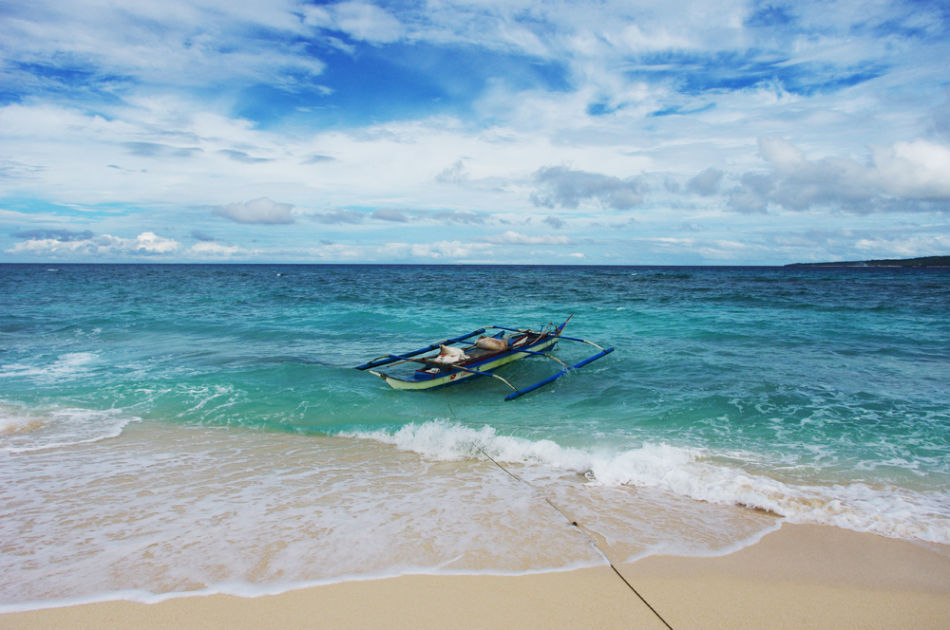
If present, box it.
[7,525,950,630]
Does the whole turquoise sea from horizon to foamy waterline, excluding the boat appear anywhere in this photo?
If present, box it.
[0,264,950,610]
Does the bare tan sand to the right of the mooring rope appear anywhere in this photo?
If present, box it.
[625,525,950,629]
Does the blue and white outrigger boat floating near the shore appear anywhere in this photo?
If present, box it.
[356,315,614,400]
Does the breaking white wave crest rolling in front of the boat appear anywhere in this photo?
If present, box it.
[347,421,950,544]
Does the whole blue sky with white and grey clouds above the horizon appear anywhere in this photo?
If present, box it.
[0,0,950,265]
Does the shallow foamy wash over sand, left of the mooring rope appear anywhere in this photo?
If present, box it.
[0,422,602,608]
